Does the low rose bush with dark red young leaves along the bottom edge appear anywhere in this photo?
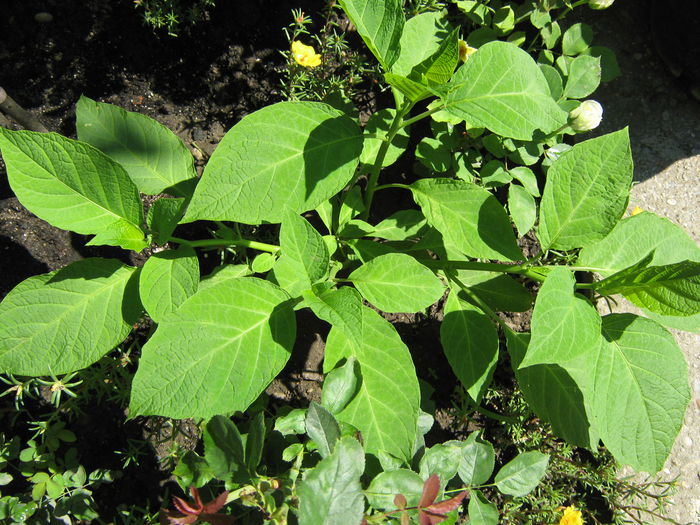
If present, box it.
[162,404,549,524]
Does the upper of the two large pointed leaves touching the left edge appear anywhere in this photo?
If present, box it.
[0,127,147,250]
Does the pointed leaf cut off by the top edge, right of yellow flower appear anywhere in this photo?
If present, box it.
[340,0,406,71]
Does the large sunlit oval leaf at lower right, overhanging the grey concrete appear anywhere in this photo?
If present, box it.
[591,314,690,473]
